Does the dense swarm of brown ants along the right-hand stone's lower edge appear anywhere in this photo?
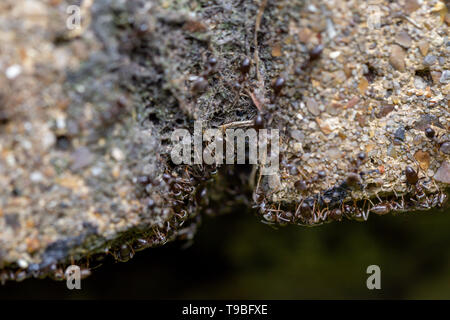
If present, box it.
[254,127,449,226]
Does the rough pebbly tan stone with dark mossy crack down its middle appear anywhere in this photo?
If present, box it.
[0,0,450,281]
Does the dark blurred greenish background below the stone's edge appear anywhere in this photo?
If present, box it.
[0,209,450,299]
